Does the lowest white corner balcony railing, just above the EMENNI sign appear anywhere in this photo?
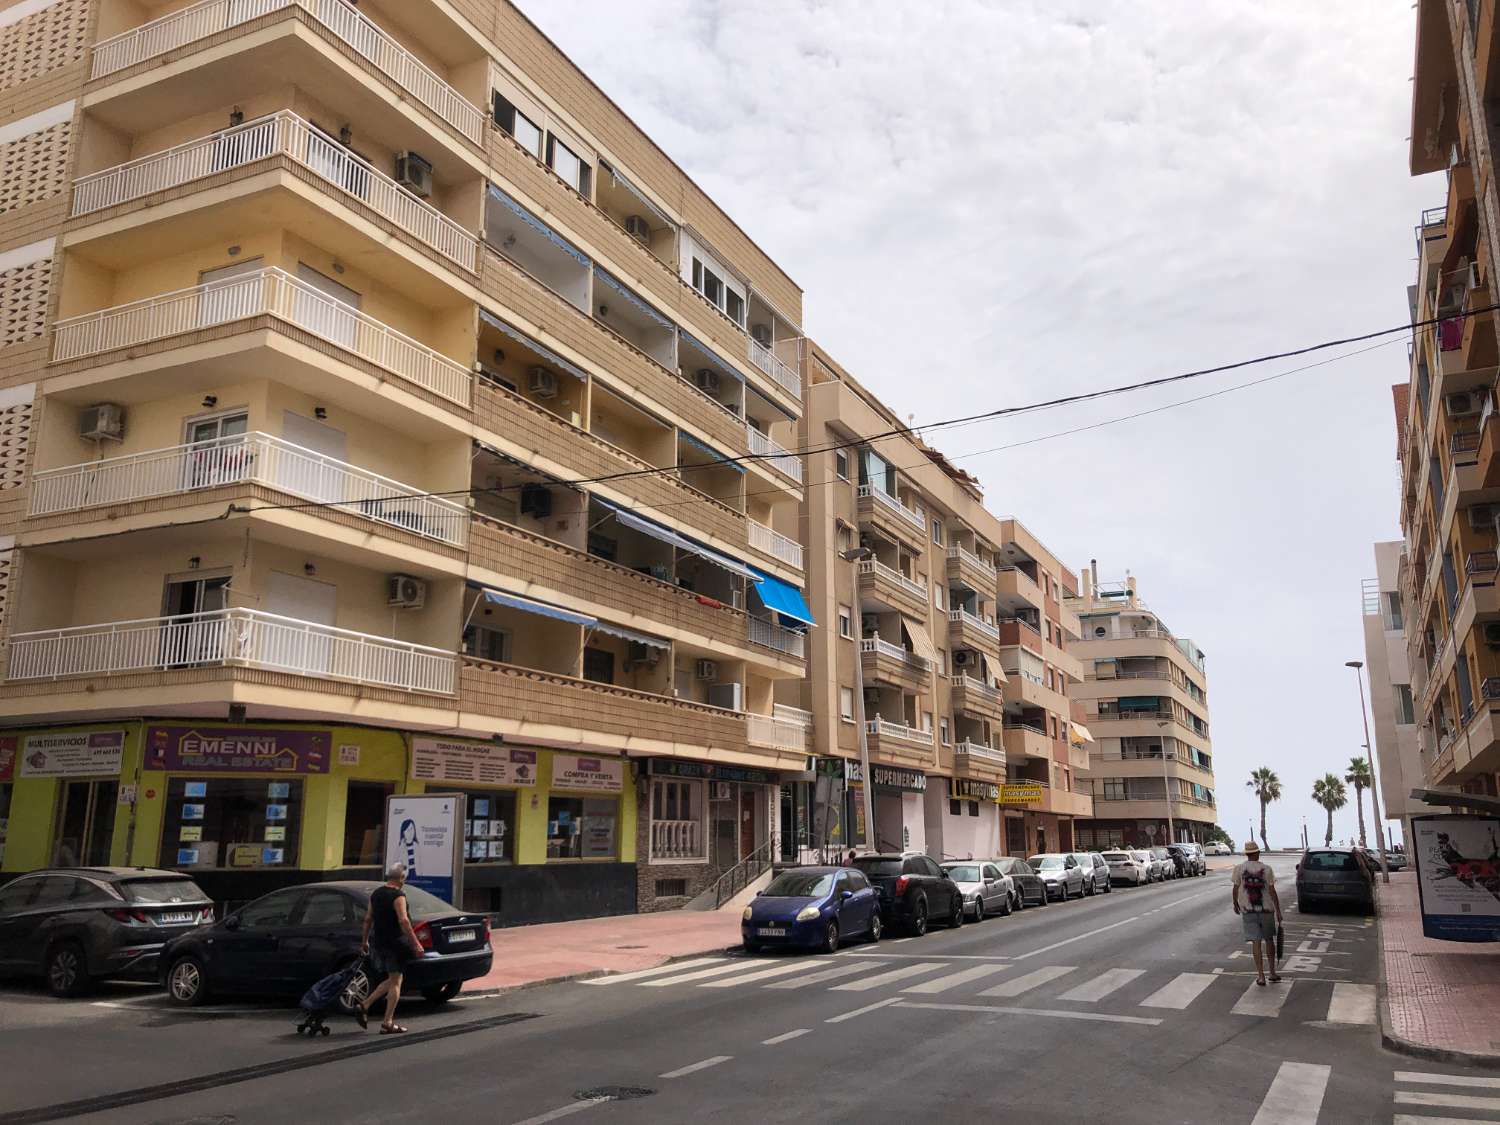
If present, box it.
[6,609,456,695]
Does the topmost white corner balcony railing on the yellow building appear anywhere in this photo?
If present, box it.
[90,0,485,144]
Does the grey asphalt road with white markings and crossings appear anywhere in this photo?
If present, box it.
[0,858,1500,1125]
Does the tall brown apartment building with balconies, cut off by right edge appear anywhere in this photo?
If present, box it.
[1397,0,1500,795]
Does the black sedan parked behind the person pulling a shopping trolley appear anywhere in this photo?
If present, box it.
[161,882,494,1011]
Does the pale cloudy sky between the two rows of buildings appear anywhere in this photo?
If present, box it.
[519,0,1428,846]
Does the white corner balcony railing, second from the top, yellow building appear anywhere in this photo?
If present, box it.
[72,110,479,273]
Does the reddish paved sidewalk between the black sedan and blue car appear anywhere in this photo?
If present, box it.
[464,911,740,993]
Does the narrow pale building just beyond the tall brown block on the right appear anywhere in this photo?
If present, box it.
[1361,546,1427,840]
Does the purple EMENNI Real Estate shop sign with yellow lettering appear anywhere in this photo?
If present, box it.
[146,726,333,774]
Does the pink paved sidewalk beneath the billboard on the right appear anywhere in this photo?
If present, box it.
[1376,872,1500,1067]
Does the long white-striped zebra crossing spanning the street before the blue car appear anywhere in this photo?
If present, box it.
[581,954,1376,1026]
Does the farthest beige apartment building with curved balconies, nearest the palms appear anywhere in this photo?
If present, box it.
[1070,563,1218,848]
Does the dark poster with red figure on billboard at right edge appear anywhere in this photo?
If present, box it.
[1412,815,1500,942]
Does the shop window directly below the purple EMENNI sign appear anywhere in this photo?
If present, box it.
[161,777,302,869]
